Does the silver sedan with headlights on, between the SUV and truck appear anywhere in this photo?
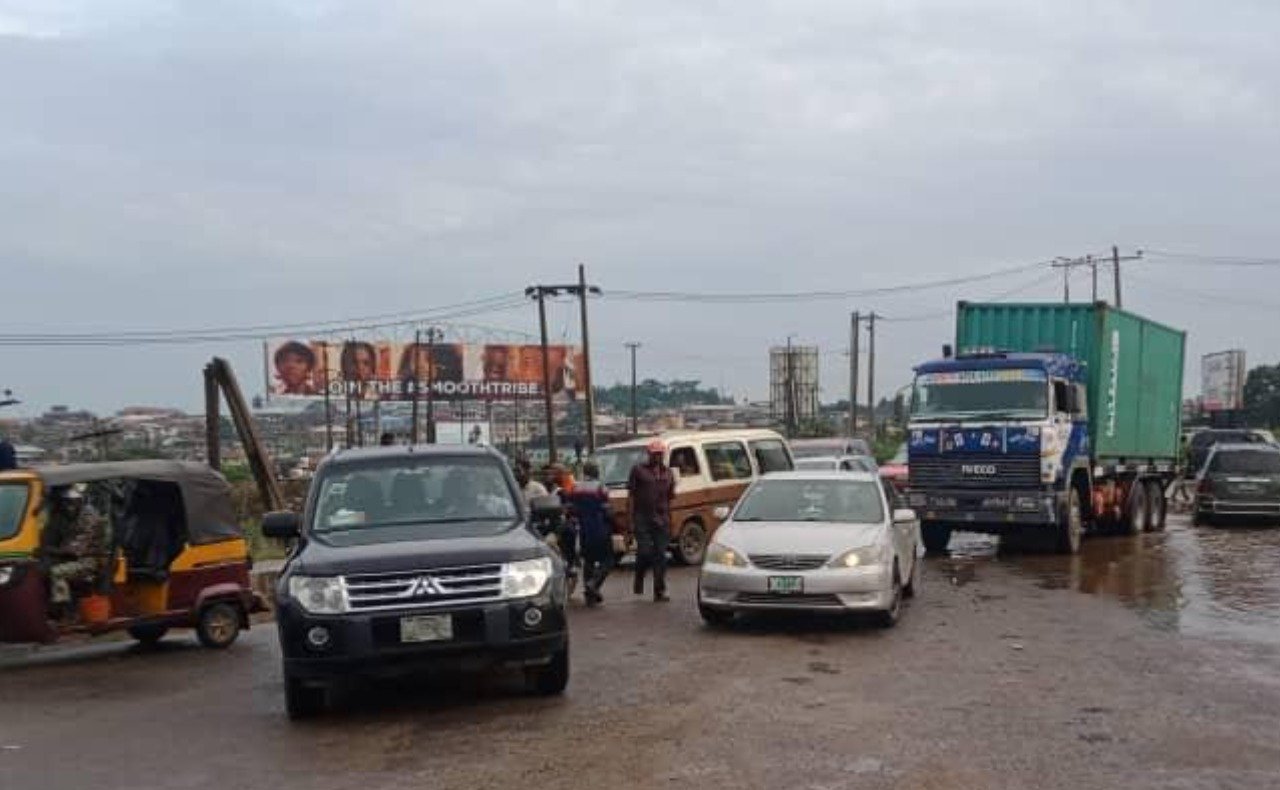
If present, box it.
[698,471,920,627]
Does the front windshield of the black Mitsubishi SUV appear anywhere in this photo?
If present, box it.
[311,456,520,533]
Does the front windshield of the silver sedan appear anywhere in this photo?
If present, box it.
[733,479,884,524]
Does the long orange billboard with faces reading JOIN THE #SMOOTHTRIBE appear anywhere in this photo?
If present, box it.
[266,339,585,401]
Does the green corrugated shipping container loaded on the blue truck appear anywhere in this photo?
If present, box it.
[956,302,1187,462]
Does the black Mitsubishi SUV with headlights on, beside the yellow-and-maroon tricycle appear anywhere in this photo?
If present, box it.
[262,447,568,718]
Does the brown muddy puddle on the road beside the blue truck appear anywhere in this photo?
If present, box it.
[940,517,1280,645]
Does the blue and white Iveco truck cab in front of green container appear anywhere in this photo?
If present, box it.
[908,351,1089,553]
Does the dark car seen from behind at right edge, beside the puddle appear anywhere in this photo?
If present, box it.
[1196,443,1280,524]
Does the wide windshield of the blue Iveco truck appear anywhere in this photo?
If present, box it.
[911,370,1048,420]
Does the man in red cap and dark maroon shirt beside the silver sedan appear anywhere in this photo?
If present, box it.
[627,439,676,603]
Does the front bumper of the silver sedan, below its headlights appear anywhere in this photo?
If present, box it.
[698,565,893,612]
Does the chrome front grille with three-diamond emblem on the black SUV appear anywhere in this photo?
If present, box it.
[344,565,502,612]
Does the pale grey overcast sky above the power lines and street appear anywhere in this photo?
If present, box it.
[0,0,1280,414]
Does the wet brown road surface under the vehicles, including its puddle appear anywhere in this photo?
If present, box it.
[0,512,1280,790]
